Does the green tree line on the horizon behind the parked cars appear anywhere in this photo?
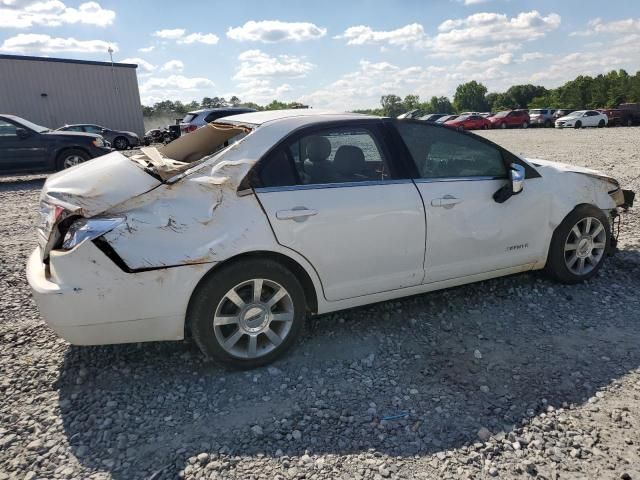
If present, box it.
[143,70,640,117]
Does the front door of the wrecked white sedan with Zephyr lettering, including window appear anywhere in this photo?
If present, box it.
[396,122,550,283]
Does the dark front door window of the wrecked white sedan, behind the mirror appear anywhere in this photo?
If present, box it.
[397,123,506,178]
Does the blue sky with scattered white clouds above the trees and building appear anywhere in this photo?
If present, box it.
[0,0,640,110]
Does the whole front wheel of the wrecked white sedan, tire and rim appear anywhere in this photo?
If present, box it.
[544,205,611,284]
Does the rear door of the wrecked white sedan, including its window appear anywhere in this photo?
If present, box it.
[255,120,425,301]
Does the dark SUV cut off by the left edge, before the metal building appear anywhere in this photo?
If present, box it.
[0,115,112,173]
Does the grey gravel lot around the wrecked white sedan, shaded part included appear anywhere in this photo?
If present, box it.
[0,128,640,480]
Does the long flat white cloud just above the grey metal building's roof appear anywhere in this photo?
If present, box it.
[0,33,118,54]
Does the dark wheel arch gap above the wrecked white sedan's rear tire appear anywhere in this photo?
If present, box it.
[184,250,318,338]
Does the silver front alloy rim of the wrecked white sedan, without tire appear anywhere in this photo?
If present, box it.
[564,217,607,275]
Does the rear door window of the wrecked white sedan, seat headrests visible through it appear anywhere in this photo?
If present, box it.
[259,127,389,187]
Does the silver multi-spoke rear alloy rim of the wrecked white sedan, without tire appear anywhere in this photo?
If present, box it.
[213,278,295,358]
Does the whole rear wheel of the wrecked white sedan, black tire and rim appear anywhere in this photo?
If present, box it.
[187,260,307,369]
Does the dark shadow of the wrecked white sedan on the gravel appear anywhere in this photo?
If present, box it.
[58,251,640,479]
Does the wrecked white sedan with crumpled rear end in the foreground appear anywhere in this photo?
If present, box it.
[27,110,633,368]
